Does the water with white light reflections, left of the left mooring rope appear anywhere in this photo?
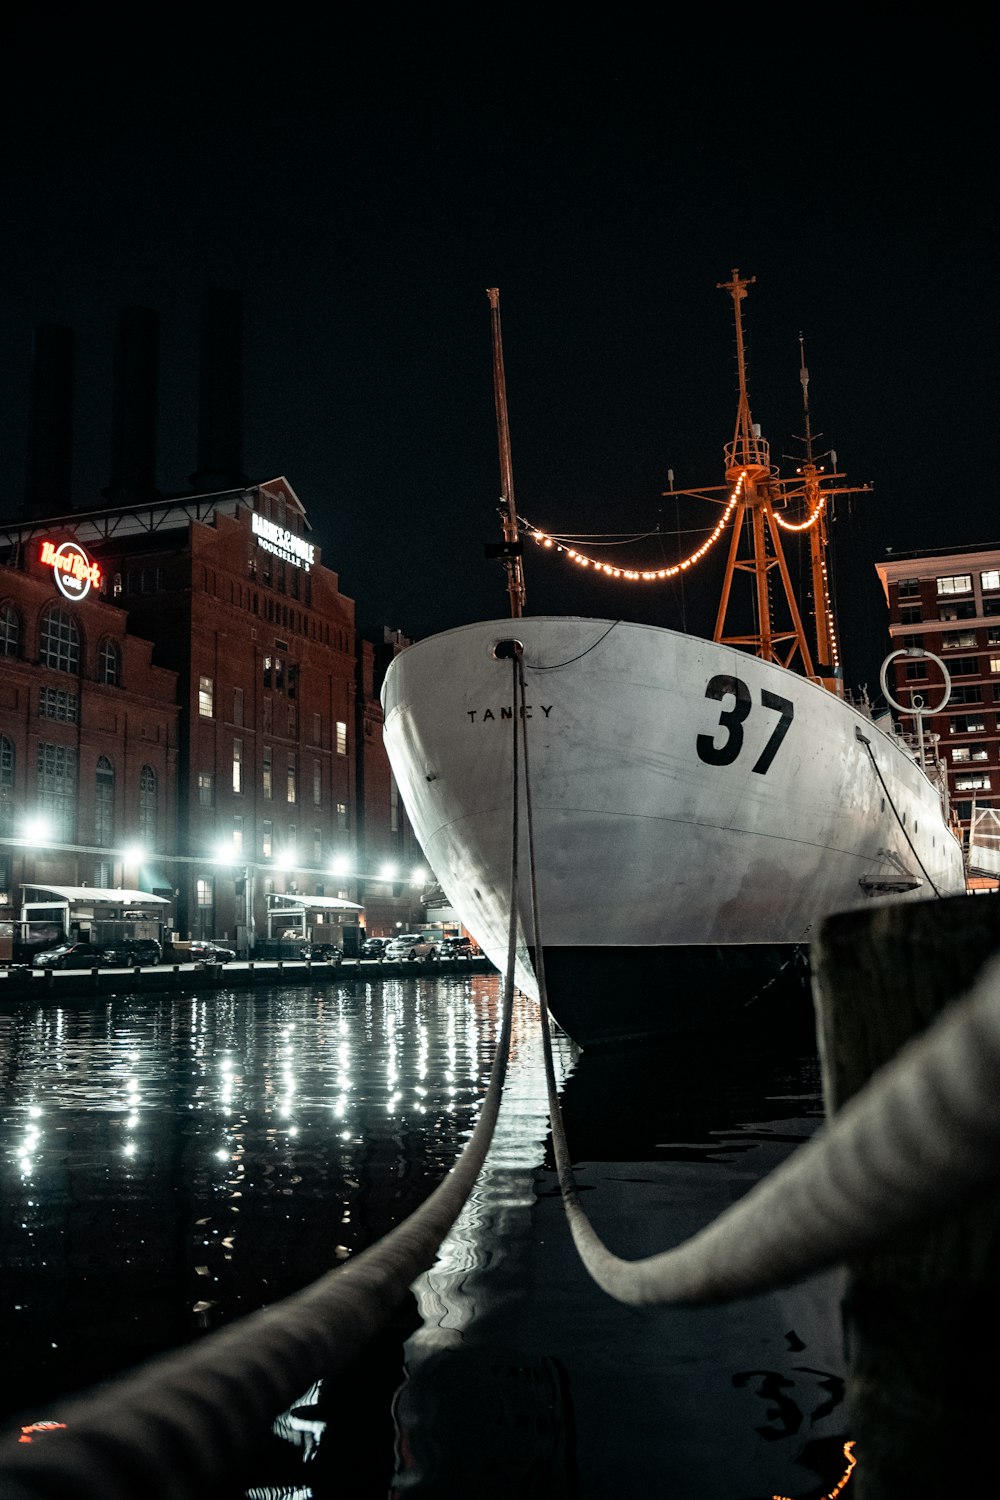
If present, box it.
[0,975,512,1413]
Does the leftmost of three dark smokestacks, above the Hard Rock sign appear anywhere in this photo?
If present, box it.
[24,324,75,519]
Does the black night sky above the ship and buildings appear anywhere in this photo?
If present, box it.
[0,17,1000,687]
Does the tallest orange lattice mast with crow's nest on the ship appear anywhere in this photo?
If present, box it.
[712,270,816,678]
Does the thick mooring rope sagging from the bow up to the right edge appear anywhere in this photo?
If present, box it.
[519,671,1000,1305]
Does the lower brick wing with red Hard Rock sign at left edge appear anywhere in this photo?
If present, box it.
[0,525,178,911]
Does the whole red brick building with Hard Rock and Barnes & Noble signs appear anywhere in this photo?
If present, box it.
[0,479,423,953]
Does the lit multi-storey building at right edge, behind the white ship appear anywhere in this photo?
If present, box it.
[876,546,1000,876]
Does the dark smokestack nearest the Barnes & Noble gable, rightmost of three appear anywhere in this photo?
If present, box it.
[189,288,249,491]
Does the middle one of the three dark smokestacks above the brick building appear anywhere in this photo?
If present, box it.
[100,308,159,504]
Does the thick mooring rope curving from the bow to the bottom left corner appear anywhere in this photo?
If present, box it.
[0,666,530,1500]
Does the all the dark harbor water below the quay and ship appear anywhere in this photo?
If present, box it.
[0,975,850,1500]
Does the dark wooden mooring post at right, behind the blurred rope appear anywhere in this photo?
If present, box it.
[811,896,1000,1500]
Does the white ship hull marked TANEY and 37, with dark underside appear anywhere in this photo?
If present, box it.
[382,617,966,1044]
